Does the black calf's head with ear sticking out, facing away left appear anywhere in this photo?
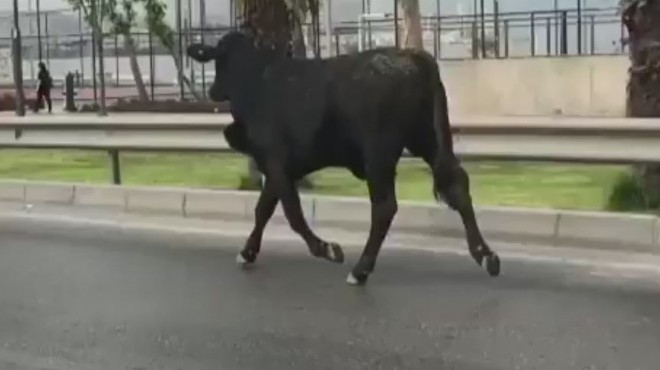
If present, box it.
[187,31,257,102]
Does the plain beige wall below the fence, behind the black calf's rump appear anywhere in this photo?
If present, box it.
[440,55,630,116]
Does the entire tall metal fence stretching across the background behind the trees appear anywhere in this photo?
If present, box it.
[0,2,627,104]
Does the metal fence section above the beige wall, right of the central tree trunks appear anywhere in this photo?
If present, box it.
[334,8,627,60]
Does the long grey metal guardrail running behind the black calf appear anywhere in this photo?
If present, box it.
[0,114,660,183]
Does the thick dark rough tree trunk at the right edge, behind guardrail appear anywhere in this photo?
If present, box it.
[621,0,660,208]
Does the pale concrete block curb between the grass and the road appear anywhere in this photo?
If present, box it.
[0,180,660,253]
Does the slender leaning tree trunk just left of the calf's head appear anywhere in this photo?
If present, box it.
[144,0,203,101]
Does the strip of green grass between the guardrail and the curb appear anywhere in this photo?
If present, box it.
[0,150,628,210]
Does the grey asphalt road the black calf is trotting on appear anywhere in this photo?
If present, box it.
[0,225,660,370]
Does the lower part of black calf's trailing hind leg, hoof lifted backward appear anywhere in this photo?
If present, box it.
[433,155,500,276]
